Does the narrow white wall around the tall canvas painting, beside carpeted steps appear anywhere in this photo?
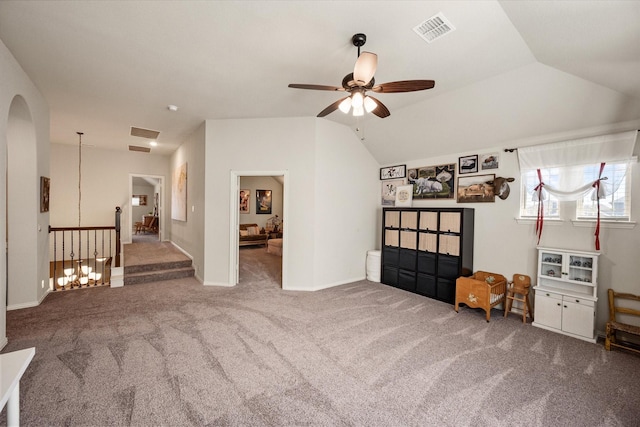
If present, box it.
[169,122,205,281]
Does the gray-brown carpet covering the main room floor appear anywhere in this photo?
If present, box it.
[2,247,640,426]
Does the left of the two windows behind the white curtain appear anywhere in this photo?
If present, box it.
[520,168,560,218]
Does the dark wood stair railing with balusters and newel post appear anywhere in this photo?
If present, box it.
[49,207,122,291]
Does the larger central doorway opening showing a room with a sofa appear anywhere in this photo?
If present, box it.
[229,171,289,289]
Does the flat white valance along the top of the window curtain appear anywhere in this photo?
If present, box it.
[518,130,638,171]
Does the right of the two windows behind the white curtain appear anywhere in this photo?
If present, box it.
[576,162,631,221]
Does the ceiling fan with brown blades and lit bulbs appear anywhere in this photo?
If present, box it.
[289,33,435,118]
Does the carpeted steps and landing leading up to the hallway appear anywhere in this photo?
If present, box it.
[124,243,195,286]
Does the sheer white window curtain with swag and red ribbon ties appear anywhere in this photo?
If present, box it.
[518,130,638,250]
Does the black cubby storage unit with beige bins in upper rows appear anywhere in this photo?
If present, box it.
[381,208,474,304]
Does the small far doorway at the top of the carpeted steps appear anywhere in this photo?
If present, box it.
[128,174,165,243]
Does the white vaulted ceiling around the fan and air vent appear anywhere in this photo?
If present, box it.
[0,0,640,164]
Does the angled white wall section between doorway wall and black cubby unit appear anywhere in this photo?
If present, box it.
[314,120,380,287]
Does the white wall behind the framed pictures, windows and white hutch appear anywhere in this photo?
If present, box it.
[398,132,640,334]
